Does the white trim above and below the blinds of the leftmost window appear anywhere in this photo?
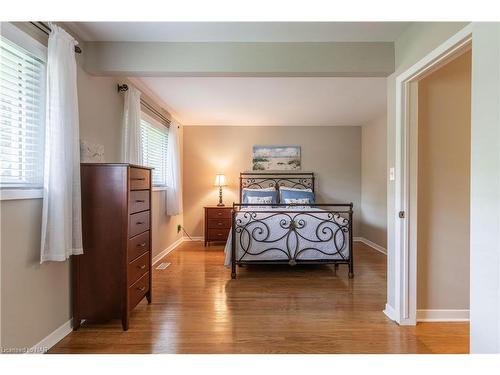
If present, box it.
[0,22,47,201]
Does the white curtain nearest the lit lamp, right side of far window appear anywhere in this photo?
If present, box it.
[166,121,182,216]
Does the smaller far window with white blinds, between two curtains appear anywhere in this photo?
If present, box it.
[141,113,168,187]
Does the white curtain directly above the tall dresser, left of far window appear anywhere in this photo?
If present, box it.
[122,85,143,165]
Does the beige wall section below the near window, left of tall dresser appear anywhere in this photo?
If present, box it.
[0,199,71,348]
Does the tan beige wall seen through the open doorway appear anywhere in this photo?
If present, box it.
[417,51,471,309]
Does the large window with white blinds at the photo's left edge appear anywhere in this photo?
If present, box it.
[0,24,46,189]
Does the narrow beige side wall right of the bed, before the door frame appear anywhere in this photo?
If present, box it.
[361,114,387,249]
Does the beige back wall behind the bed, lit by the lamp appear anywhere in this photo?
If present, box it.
[184,126,361,236]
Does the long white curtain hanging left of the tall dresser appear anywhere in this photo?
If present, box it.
[40,24,83,263]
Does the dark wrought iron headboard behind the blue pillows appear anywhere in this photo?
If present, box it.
[240,172,314,202]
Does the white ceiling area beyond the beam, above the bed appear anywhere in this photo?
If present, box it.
[140,77,386,126]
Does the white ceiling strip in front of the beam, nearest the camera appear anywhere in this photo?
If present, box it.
[70,22,409,42]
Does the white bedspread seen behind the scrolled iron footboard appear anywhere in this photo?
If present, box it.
[224,207,349,267]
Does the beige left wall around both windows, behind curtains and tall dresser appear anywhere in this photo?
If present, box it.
[0,24,182,348]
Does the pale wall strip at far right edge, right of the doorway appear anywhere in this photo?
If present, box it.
[470,22,500,353]
